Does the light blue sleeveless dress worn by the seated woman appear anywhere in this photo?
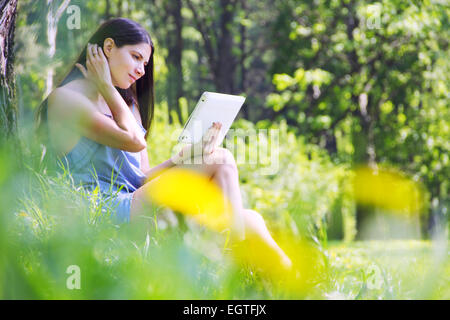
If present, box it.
[57,104,146,223]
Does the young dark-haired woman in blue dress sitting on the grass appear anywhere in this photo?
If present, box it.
[38,18,291,268]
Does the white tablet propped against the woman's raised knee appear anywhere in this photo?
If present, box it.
[178,92,245,147]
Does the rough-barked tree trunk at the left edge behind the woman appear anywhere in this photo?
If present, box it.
[0,0,17,144]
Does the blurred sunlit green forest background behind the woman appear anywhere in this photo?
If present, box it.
[0,0,450,298]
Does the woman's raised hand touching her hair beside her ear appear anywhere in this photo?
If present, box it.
[75,43,112,90]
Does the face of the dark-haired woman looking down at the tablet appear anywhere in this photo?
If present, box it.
[103,38,152,89]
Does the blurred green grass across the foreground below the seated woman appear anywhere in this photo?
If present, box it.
[7,165,450,299]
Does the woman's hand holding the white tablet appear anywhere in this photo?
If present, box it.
[171,122,222,164]
